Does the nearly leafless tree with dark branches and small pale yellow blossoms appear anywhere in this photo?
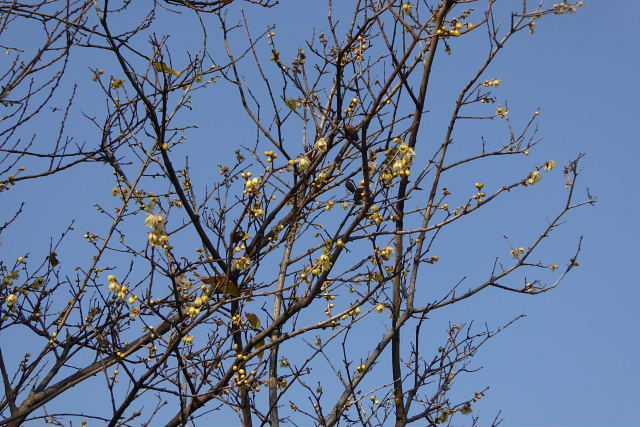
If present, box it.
[0,0,595,427]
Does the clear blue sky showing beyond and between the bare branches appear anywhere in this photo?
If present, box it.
[0,0,640,426]
